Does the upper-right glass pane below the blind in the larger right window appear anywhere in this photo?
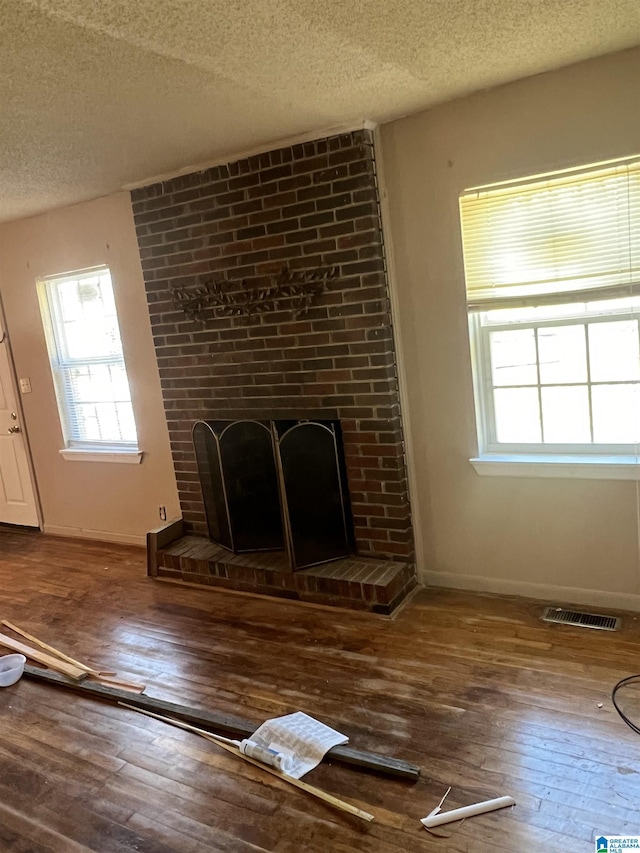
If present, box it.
[589,320,640,382]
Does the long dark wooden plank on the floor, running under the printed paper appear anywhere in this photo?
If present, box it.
[24,666,420,782]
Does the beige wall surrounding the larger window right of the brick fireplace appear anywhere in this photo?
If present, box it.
[378,49,640,608]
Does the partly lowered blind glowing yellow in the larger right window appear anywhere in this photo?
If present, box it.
[460,158,640,311]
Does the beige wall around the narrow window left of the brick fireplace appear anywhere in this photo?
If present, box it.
[0,193,180,543]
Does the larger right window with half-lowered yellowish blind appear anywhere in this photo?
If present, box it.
[460,159,640,458]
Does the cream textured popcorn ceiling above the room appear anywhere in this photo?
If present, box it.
[0,0,640,220]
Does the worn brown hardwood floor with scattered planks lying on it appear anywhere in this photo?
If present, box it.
[0,530,640,853]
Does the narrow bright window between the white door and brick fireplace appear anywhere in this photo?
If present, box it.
[38,267,137,451]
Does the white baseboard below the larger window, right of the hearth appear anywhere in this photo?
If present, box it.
[420,571,640,611]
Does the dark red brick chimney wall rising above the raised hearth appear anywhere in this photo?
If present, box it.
[132,130,413,560]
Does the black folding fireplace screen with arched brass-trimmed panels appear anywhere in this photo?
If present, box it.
[193,420,353,569]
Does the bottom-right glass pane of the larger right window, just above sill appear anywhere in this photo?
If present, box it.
[591,384,640,444]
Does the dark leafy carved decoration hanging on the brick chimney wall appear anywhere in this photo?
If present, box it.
[171,267,338,325]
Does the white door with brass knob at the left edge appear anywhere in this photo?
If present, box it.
[0,327,38,527]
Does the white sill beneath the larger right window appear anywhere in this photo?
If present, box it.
[469,454,640,480]
